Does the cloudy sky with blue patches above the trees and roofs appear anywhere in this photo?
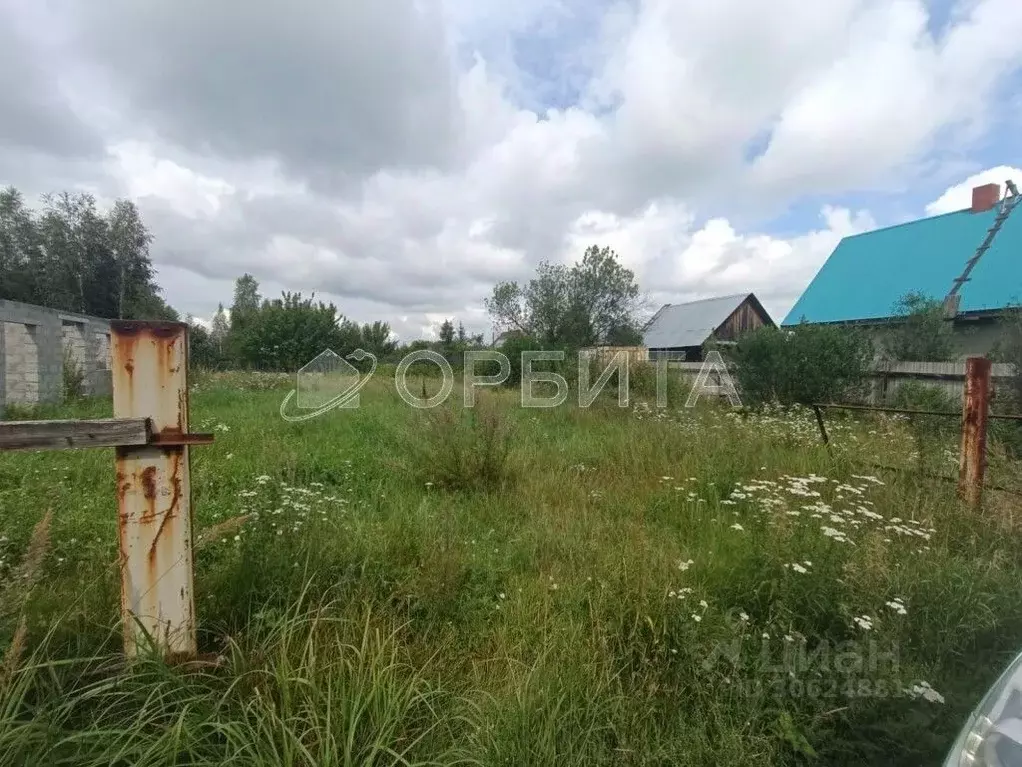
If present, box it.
[0,0,1022,339]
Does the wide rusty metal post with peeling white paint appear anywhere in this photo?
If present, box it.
[110,321,196,660]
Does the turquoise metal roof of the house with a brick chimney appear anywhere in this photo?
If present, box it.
[781,206,1022,325]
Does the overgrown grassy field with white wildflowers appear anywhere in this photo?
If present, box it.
[0,374,1022,767]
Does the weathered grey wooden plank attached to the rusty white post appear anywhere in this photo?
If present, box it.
[0,418,149,451]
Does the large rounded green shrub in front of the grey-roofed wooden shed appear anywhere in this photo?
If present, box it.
[734,323,873,405]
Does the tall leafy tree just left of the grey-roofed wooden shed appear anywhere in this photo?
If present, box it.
[485,245,639,348]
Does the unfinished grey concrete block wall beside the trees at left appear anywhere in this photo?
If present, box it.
[0,301,110,410]
